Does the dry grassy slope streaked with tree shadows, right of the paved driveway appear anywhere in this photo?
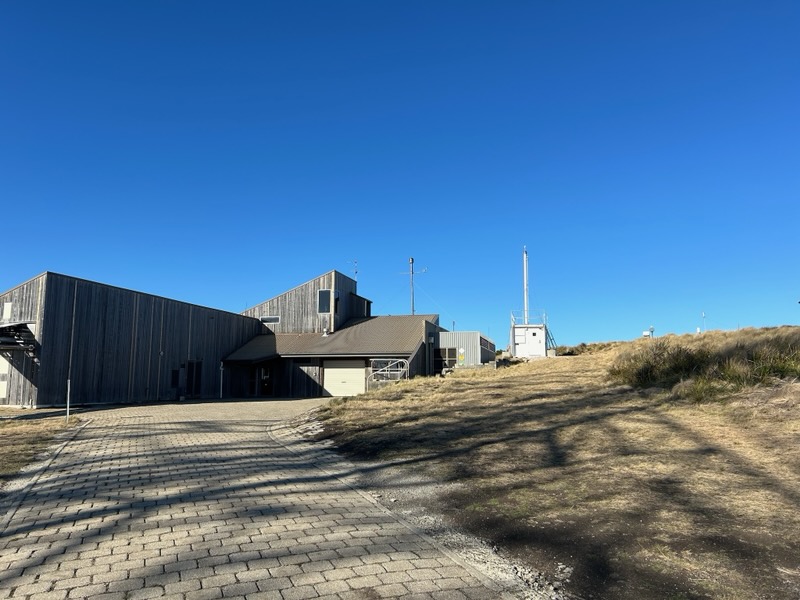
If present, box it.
[316,332,800,599]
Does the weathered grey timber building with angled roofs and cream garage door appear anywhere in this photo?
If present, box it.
[0,271,494,408]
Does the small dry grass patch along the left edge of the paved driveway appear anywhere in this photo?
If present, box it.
[0,408,78,489]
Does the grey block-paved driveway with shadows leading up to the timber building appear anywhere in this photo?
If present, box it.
[0,400,510,600]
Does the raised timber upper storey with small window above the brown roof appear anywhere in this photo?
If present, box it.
[242,271,362,333]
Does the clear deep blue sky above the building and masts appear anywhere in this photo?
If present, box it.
[0,0,800,347]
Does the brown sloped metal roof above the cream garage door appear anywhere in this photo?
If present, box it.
[225,315,438,362]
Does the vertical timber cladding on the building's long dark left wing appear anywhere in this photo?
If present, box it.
[0,273,263,406]
